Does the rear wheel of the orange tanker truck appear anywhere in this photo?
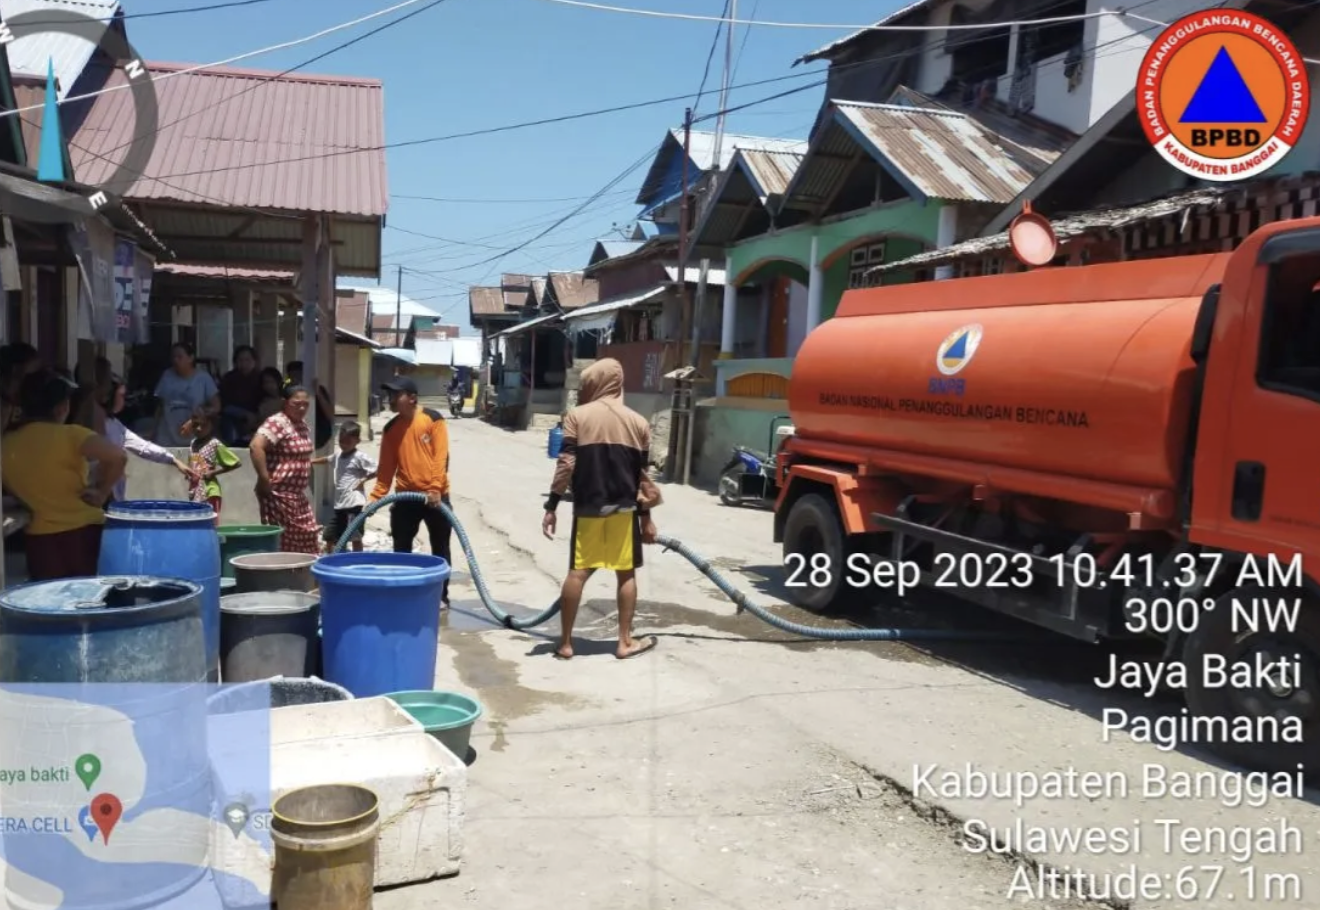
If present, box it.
[784,493,849,613]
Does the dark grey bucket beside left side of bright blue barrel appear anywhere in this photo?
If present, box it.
[220,590,321,683]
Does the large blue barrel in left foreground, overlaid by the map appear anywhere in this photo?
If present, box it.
[0,577,211,910]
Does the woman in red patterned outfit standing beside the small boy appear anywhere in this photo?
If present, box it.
[248,386,321,556]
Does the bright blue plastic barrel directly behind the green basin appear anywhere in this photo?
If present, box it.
[312,552,449,699]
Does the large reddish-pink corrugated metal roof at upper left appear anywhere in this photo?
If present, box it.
[69,63,389,218]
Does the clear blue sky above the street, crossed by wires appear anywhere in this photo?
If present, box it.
[124,0,900,330]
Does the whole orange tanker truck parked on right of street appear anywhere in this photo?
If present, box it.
[775,218,1320,771]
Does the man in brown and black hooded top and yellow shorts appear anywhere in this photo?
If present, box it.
[541,358,660,660]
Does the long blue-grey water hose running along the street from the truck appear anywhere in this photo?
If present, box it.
[334,493,1022,642]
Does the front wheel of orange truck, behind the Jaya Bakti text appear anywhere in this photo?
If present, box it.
[1183,588,1320,773]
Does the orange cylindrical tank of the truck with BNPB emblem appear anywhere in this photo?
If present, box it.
[789,256,1218,489]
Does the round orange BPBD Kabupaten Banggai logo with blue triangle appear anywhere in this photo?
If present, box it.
[1137,9,1311,182]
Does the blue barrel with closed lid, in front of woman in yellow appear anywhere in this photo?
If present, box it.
[96,499,222,682]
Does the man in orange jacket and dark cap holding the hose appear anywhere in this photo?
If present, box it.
[368,376,453,608]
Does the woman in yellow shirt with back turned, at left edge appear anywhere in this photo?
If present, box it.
[0,370,128,581]
